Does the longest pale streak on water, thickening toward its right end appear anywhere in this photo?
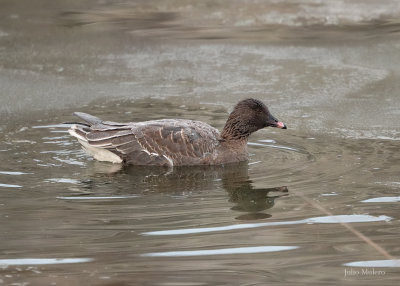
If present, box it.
[142,215,392,235]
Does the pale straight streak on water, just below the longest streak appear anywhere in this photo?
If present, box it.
[141,246,299,257]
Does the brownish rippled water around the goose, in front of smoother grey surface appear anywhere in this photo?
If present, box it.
[0,100,400,285]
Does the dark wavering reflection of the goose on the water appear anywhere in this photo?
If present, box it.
[76,162,288,220]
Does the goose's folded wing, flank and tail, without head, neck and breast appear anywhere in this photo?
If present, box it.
[70,113,219,166]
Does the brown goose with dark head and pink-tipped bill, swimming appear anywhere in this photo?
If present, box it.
[69,98,286,166]
